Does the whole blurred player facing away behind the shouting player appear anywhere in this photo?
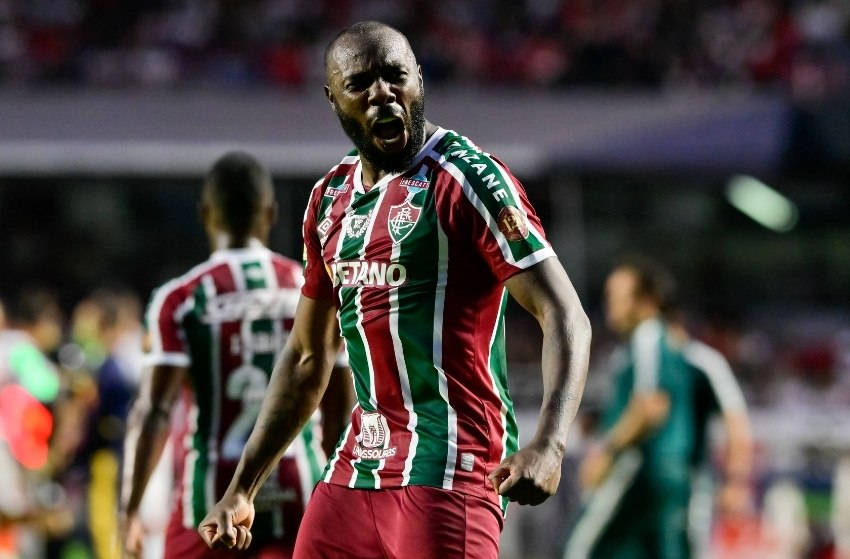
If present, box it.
[119,152,350,559]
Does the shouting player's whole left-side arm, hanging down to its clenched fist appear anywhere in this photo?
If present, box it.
[198,295,340,549]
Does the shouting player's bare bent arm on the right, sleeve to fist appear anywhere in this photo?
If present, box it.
[489,257,591,505]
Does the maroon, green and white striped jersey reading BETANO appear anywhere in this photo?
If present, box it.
[302,129,554,512]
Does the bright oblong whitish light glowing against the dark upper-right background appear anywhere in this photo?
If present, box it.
[726,175,797,233]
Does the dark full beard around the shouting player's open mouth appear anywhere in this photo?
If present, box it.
[334,93,425,173]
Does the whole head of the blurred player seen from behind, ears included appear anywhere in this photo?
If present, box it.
[201,151,277,250]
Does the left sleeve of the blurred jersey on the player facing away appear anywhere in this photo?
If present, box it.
[144,280,191,367]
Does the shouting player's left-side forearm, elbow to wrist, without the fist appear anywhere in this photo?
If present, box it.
[229,348,332,499]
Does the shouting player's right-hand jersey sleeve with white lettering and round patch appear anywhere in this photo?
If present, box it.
[443,134,555,281]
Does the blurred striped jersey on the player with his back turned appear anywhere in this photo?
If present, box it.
[145,242,324,531]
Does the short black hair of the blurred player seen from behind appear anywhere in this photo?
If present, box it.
[203,151,274,237]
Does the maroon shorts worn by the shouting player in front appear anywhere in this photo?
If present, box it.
[295,483,503,559]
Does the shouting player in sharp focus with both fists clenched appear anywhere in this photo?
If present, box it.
[199,22,590,559]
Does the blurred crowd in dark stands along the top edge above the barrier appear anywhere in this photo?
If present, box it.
[0,0,850,100]
